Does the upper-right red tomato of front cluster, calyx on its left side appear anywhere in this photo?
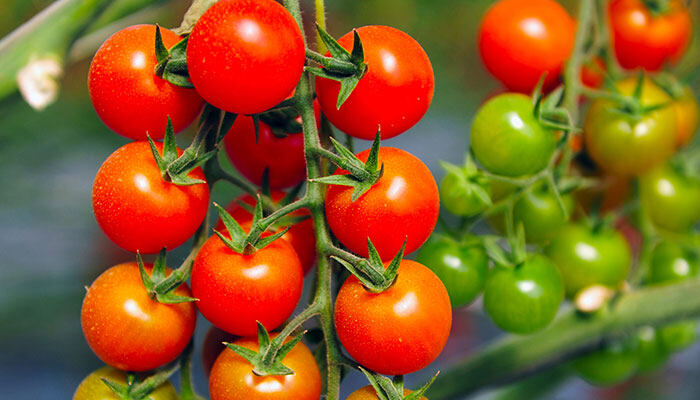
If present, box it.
[316,25,435,140]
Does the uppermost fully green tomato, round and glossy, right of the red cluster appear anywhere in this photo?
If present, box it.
[471,93,557,177]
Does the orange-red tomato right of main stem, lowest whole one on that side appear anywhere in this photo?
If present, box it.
[335,260,452,375]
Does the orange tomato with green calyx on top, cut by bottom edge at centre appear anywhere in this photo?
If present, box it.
[209,334,321,400]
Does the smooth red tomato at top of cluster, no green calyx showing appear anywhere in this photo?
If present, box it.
[187,0,305,114]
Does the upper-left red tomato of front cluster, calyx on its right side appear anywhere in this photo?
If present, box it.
[88,25,202,140]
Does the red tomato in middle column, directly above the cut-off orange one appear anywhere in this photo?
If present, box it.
[191,235,304,336]
